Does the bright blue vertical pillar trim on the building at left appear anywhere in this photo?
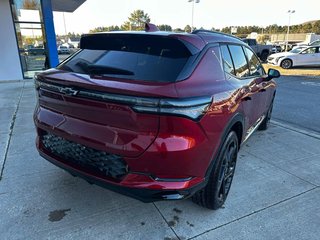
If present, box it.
[41,0,59,68]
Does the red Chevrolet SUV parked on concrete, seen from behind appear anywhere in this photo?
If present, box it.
[34,25,279,209]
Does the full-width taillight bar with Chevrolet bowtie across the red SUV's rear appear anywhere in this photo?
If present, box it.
[35,79,212,120]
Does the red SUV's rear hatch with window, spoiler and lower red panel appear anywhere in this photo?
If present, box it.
[35,33,199,157]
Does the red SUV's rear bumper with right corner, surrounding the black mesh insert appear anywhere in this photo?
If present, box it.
[34,104,218,202]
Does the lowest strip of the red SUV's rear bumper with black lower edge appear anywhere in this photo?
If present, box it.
[37,138,206,203]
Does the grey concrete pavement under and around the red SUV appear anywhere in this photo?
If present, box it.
[0,81,320,240]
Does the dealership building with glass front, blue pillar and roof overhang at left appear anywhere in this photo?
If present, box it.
[0,0,85,81]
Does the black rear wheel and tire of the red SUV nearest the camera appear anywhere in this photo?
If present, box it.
[192,131,239,210]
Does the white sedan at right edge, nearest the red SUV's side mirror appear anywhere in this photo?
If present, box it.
[267,45,320,69]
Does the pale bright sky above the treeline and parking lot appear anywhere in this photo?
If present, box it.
[54,0,320,34]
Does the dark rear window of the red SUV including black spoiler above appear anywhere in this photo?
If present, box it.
[58,34,192,82]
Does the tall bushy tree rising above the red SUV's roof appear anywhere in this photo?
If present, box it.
[121,10,150,31]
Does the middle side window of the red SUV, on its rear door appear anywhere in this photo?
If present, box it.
[229,45,250,78]
